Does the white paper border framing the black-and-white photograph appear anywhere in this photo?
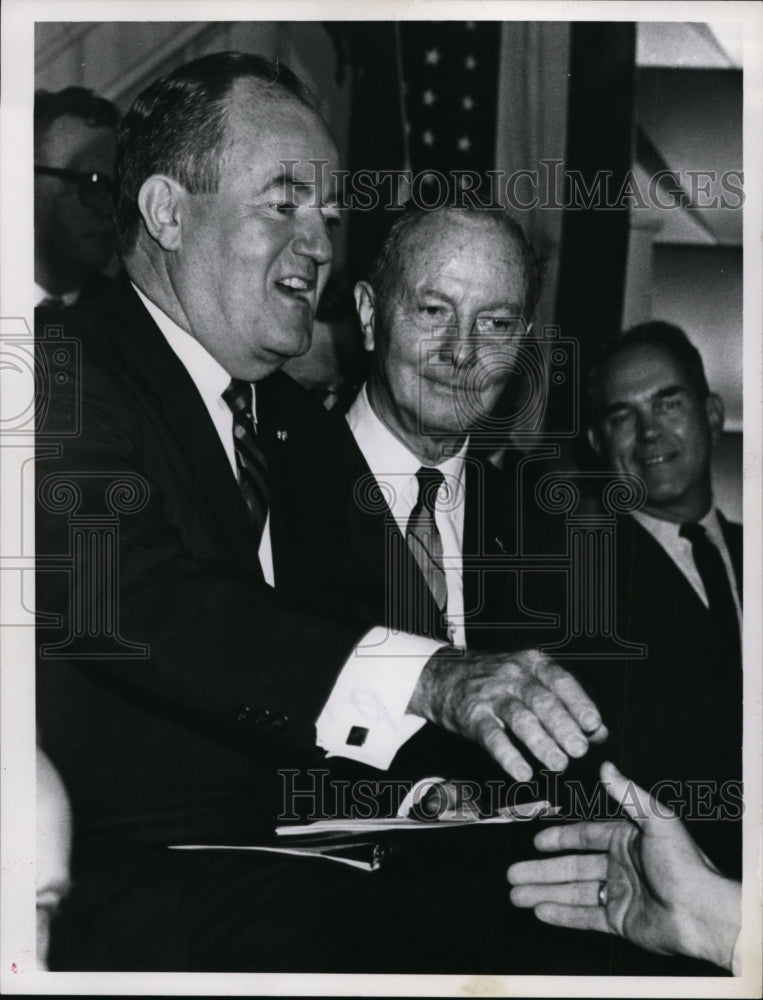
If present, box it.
[0,0,763,997]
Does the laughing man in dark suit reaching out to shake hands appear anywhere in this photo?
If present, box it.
[37,53,602,971]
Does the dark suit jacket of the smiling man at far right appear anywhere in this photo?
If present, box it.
[565,516,742,877]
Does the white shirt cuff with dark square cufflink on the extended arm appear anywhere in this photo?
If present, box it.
[316,627,442,770]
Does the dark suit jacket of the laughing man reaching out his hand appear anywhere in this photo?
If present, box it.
[37,281,363,868]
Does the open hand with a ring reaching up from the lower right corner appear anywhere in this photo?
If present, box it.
[507,763,741,968]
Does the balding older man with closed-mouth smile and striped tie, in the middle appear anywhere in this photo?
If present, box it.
[314,205,568,780]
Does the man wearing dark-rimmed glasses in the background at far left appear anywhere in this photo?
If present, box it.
[34,87,119,308]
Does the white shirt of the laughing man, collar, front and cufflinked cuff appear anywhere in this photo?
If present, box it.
[133,285,441,769]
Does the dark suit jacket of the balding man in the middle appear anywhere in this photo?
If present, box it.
[304,422,548,781]
